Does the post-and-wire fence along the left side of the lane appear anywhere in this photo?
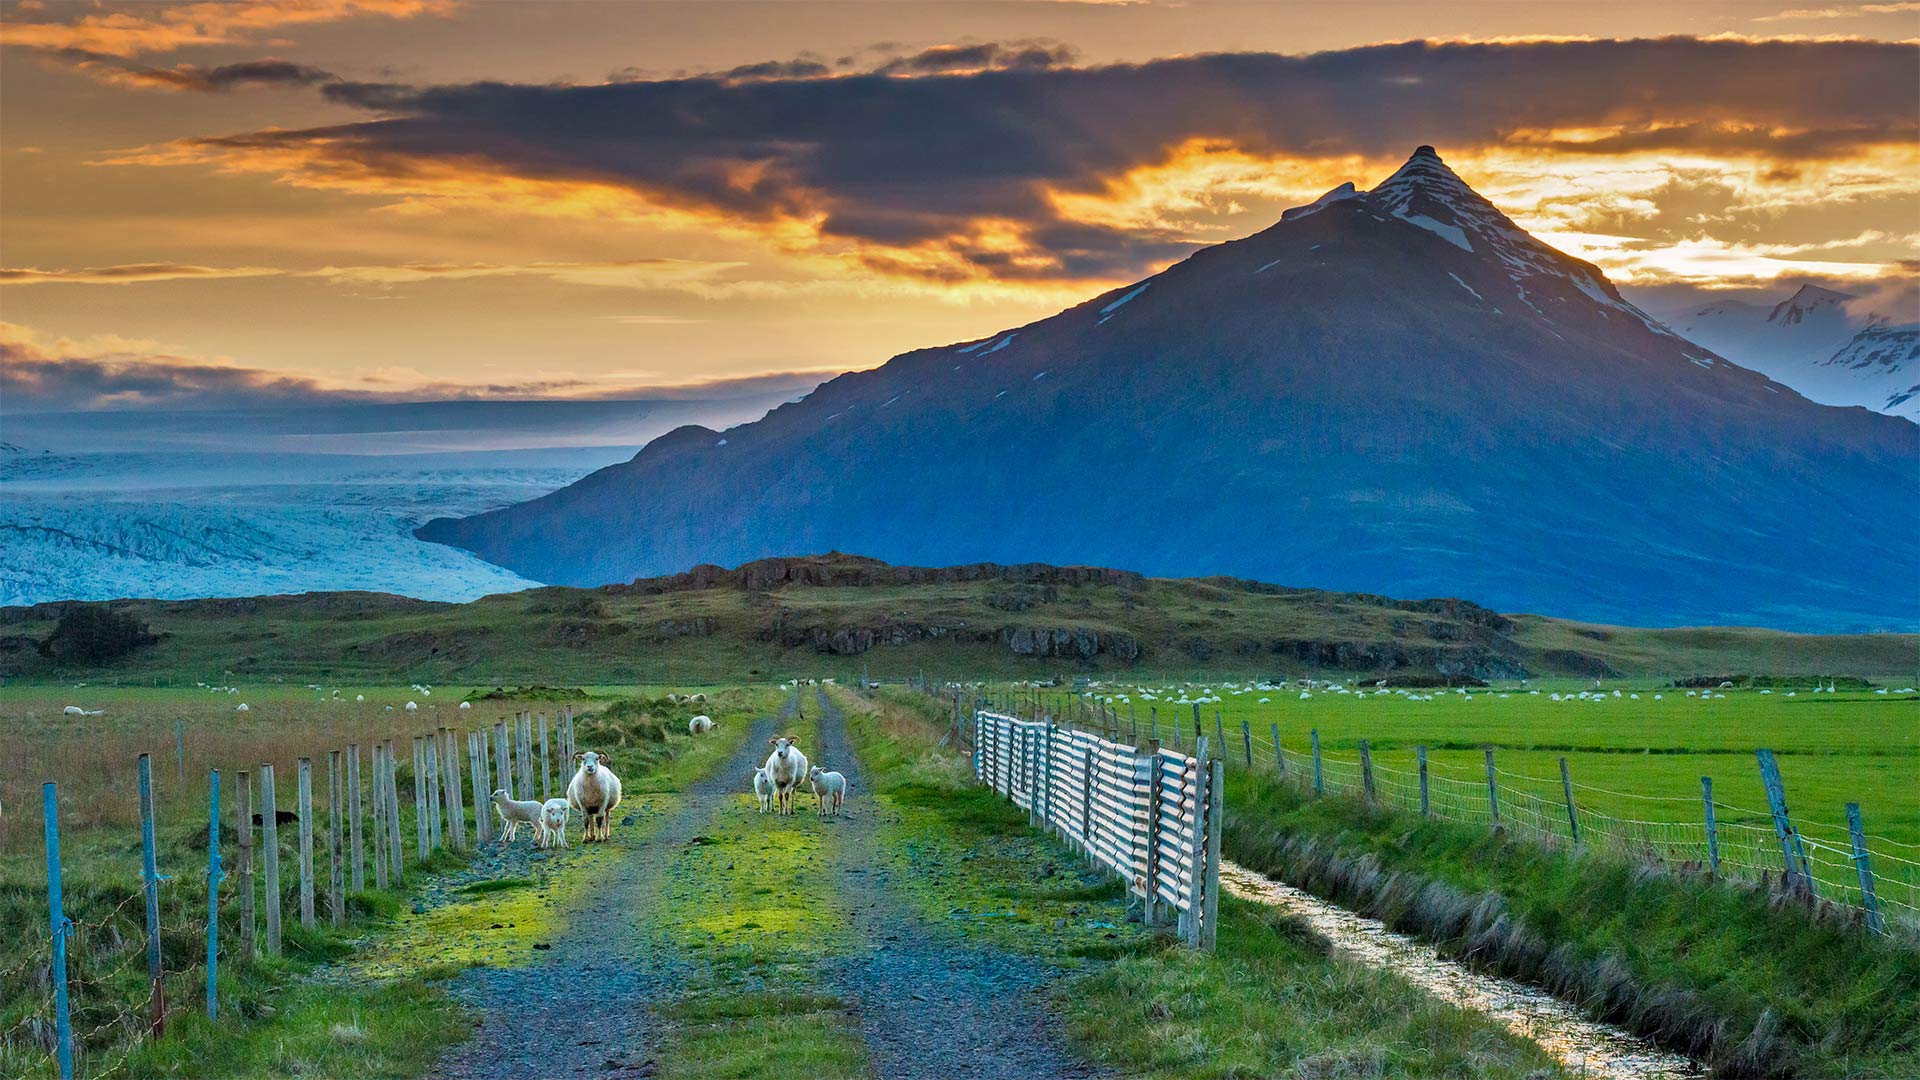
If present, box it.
[0,707,574,1080]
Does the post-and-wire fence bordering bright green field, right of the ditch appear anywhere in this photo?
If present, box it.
[922,684,1920,938]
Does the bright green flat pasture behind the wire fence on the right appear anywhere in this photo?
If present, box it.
[983,680,1920,928]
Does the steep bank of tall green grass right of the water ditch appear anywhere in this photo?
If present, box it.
[1223,774,1920,1078]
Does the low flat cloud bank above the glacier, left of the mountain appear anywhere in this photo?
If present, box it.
[0,325,828,415]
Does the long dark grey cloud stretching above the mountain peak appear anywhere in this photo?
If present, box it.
[165,38,1920,277]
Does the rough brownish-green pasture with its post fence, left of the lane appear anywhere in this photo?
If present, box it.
[0,684,599,1076]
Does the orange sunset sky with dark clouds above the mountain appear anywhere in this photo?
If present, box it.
[0,0,1920,413]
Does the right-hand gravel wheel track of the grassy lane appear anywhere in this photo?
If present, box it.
[806,690,1110,1080]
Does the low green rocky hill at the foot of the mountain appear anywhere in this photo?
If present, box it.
[0,553,1920,684]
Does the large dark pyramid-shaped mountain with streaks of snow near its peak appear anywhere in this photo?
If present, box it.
[419,146,1920,630]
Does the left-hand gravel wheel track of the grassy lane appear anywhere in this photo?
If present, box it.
[434,696,799,1080]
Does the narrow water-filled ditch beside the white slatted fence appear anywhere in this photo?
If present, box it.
[1219,861,1707,1080]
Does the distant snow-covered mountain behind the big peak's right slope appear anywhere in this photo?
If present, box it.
[1667,284,1920,421]
